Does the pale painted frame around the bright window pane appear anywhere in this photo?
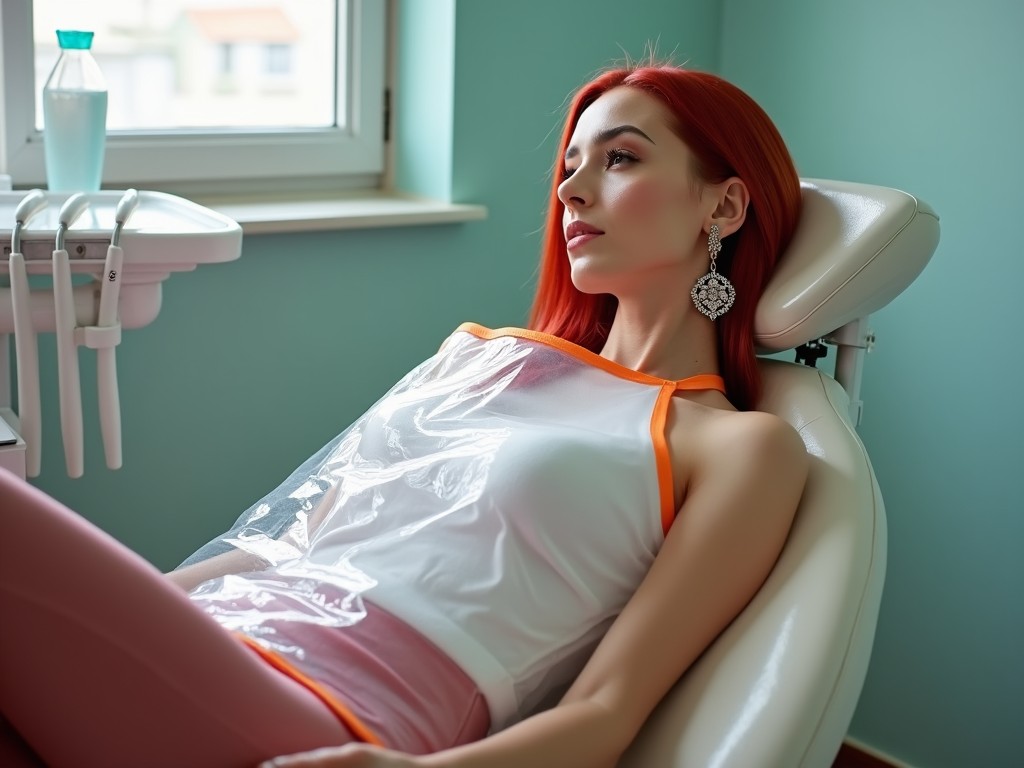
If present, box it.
[0,0,388,194]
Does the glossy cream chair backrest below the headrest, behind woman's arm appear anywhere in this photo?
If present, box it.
[620,360,886,768]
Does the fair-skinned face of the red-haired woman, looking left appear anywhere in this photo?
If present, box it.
[558,87,714,299]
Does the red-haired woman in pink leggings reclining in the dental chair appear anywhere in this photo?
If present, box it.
[0,67,806,768]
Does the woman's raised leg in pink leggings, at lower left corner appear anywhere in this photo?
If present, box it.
[0,470,486,768]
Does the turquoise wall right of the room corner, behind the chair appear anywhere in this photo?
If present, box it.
[721,0,1024,768]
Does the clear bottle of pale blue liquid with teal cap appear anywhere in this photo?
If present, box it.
[43,30,106,191]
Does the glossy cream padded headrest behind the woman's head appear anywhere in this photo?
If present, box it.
[754,179,939,352]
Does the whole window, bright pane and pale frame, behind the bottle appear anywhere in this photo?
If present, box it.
[0,0,387,193]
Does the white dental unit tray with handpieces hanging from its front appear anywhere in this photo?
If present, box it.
[0,189,242,477]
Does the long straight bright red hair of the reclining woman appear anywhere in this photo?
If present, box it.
[529,66,801,410]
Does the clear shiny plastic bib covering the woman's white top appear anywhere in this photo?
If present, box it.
[183,326,664,727]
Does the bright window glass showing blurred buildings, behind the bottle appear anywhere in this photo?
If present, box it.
[33,0,346,132]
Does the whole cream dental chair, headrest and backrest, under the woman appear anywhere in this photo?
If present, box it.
[618,180,939,768]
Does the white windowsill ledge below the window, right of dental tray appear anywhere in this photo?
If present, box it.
[196,190,487,234]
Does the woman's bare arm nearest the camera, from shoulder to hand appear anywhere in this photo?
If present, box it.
[274,414,807,768]
